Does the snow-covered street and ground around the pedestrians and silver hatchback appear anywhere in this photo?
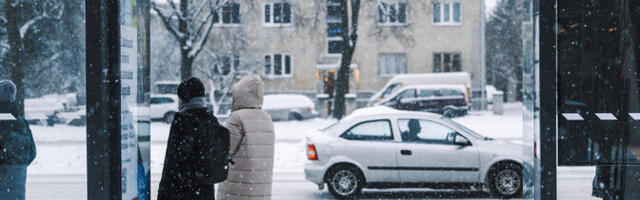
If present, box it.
[22,104,595,200]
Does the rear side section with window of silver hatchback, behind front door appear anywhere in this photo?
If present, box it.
[340,119,400,183]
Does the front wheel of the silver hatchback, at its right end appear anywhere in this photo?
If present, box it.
[489,163,524,199]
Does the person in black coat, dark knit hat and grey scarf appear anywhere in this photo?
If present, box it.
[158,78,219,200]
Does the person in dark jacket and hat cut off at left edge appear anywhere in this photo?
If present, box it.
[0,80,36,200]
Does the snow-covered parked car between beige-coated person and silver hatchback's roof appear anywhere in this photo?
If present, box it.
[262,94,318,121]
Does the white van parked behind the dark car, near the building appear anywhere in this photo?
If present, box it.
[368,72,471,106]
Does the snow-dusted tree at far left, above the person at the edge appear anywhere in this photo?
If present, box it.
[2,0,64,114]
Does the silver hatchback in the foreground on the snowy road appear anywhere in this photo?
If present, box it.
[304,106,531,198]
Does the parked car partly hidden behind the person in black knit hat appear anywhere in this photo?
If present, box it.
[149,94,180,124]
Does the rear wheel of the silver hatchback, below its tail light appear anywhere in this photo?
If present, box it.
[327,165,365,199]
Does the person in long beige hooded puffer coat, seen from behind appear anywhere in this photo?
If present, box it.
[217,75,274,200]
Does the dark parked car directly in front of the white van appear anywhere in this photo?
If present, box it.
[377,85,469,117]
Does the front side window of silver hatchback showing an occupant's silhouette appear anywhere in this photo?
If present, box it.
[398,119,458,145]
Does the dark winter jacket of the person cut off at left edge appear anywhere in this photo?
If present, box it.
[0,102,36,166]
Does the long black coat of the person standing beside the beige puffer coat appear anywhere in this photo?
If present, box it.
[158,108,220,200]
